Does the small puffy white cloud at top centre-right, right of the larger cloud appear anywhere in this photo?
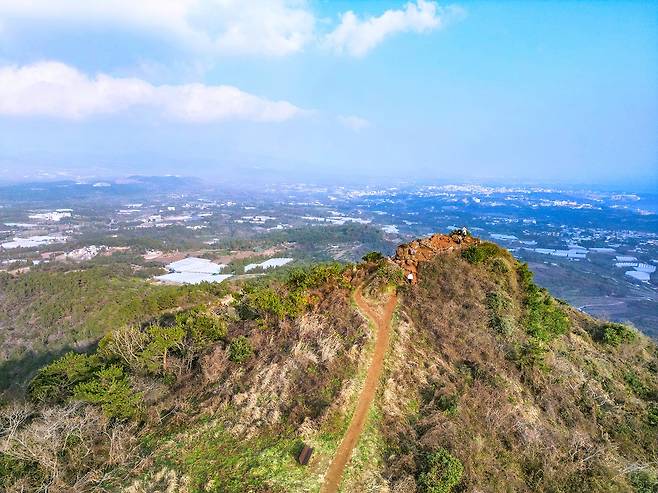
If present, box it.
[325,0,458,57]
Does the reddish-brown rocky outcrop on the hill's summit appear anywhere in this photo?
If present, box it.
[393,228,480,284]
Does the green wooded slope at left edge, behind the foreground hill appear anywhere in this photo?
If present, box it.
[0,264,223,396]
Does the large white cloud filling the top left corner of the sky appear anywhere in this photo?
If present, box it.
[0,0,315,56]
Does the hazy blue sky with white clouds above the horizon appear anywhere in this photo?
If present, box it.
[0,0,658,190]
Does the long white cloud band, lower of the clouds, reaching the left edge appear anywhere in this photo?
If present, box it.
[0,62,305,123]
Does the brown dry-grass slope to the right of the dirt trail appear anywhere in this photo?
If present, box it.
[381,251,658,492]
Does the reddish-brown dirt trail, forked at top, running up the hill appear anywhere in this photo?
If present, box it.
[320,286,397,493]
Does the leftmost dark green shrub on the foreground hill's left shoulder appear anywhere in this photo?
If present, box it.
[28,353,101,403]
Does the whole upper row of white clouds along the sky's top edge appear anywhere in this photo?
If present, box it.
[0,0,456,57]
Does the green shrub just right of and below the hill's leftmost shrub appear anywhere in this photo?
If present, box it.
[73,365,142,421]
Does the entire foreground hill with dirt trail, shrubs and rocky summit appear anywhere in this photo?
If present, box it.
[0,232,658,493]
